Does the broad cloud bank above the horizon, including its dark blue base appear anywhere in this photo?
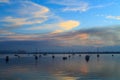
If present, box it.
[0,26,120,52]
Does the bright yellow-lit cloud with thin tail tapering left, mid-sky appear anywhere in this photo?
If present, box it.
[26,20,80,33]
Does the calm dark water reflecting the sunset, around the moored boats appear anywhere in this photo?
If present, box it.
[0,54,120,80]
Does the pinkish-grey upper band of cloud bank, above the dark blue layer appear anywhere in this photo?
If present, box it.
[1,26,120,46]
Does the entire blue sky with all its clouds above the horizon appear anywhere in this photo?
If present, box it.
[0,0,120,51]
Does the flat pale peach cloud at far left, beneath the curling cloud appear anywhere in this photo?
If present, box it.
[1,16,46,27]
